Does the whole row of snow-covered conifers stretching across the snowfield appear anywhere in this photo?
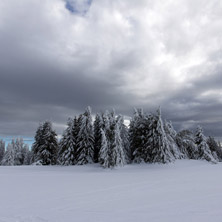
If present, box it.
[0,107,222,168]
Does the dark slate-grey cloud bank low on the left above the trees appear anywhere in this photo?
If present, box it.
[0,59,134,135]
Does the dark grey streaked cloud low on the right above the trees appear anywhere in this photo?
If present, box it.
[159,67,222,138]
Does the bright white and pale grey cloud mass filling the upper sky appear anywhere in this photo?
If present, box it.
[0,0,222,136]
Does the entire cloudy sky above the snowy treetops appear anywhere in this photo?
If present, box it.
[0,0,222,138]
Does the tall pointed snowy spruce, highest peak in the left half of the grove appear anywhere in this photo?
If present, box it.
[76,107,94,165]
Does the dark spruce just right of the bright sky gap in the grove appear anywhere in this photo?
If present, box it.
[129,109,147,163]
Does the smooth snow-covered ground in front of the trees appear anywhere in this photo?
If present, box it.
[0,160,222,222]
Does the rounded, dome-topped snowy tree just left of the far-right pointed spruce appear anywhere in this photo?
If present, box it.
[176,130,199,159]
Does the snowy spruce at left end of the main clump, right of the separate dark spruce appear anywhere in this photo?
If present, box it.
[59,117,77,165]
